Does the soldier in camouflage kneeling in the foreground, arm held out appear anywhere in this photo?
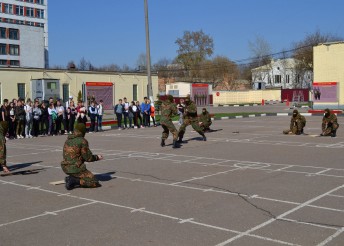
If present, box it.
[61,123,103,190]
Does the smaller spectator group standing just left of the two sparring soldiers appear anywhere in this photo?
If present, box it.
[114,97,156,130]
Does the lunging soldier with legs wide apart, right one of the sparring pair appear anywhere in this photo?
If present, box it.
[178,96,207,143]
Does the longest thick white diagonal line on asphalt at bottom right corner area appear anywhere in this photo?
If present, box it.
[217,185,344,246]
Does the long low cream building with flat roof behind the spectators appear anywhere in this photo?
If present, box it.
[0,67,158,109]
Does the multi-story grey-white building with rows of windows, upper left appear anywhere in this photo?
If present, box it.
[0,0,49,68]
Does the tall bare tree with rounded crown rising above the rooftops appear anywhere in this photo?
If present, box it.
[175,30,214,75]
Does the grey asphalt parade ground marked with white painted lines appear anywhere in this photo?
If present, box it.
[0,112,344,246]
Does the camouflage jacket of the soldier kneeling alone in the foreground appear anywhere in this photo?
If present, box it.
[61,134,98,173]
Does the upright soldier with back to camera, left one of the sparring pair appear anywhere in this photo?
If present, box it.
[160,95,179,148]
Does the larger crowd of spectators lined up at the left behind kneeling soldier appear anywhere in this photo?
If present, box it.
[0,96,104,139]
